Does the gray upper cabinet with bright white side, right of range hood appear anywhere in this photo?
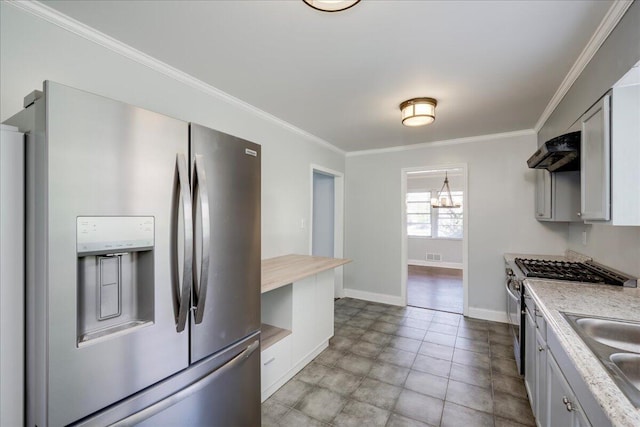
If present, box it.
[580,83,640,226]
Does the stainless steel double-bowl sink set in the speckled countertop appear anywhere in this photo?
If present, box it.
[561,313,640,408]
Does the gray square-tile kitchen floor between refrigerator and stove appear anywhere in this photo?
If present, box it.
[262,298,535,427]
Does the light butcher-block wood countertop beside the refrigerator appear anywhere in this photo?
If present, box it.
[262,255,351,293]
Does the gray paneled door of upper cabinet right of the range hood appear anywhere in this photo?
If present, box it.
[580,94,611,221]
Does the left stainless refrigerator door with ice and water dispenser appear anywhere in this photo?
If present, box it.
[27,82,191,426]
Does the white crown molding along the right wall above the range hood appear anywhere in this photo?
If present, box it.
[533,0,633,133]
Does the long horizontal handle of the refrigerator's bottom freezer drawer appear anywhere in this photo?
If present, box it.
[111,339,260,427]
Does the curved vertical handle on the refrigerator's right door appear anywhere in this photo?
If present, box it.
[193,154,211,324]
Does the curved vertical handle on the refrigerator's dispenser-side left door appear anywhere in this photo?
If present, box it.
[175,153,193,332]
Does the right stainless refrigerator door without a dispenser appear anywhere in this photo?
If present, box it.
[190,124,261,363]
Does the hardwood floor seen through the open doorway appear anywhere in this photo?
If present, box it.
[407,265,462,313]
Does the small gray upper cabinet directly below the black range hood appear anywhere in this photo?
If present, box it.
[535,169,580,222]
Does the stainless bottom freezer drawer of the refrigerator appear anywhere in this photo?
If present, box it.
[74,334,261,427]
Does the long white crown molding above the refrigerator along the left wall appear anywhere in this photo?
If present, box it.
[6,0,346,155]
